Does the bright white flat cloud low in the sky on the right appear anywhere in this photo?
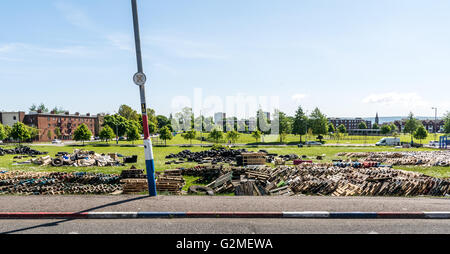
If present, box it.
[363,92,429,107]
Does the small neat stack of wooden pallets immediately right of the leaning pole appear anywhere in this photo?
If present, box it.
[156,170,186,195]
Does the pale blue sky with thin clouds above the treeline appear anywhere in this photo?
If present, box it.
[0,0,450,117]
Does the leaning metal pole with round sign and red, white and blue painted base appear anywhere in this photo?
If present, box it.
[131,0,157,197]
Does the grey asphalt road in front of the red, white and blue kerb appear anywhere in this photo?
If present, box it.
[0,219,450,234]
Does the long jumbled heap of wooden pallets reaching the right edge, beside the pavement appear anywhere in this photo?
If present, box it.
[179,163,450,196]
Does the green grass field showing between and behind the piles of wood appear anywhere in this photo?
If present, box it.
[0,145,450,181]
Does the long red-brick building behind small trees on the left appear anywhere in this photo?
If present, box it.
[23,112,102,142]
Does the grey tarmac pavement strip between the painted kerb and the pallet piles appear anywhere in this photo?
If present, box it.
[0,195,450,212]
